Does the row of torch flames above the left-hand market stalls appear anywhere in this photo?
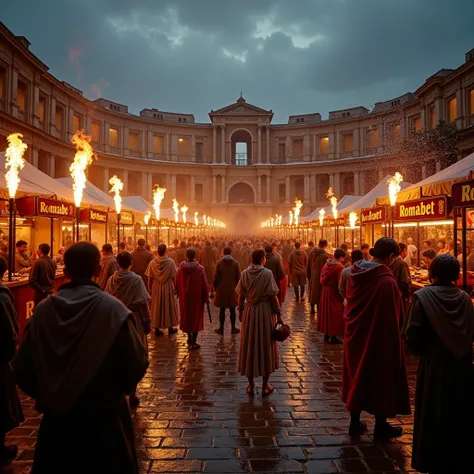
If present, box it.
[5,130,226,228]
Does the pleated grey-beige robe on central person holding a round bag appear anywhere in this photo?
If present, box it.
[237,265,279,377]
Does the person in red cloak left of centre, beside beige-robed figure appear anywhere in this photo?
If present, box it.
[176,248,209,350]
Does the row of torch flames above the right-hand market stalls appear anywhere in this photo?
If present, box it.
[261,171,403,229]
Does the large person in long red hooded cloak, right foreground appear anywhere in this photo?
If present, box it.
[342,238,411,438]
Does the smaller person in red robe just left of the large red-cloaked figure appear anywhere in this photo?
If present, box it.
[318,249,346,344]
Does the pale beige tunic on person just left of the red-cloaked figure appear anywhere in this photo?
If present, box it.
[145,255,178,329]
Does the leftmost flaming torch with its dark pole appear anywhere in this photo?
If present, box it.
[5,133,28,281]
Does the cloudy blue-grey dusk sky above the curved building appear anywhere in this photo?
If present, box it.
[0,0,474,123]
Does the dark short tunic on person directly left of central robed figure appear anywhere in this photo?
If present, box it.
[214,255,240,308]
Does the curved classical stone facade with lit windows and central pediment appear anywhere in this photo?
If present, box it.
[0,23,474,230]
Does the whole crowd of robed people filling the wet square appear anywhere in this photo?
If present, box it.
[0,236,474,474]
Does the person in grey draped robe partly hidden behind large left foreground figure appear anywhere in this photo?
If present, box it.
[105,252,151,407]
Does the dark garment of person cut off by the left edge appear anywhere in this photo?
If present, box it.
[0,283,24,435]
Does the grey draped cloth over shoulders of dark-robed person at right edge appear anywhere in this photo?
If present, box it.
[408,285,474,359]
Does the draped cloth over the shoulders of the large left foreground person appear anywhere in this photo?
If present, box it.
[28,281,131,416]
